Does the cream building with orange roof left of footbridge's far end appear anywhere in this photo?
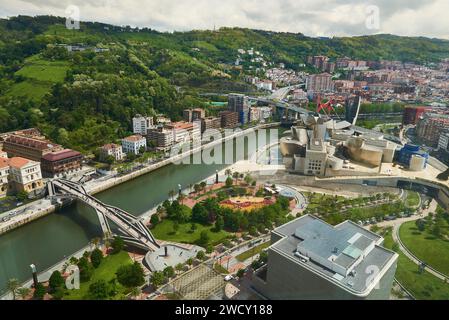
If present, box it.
[8,157,45,195]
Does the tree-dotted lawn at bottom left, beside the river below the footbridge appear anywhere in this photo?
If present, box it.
[64,251,132,300]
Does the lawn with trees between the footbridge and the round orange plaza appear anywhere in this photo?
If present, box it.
[151,219,231,245]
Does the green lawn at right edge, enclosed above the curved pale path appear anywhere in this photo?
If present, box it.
[399,222,449,275]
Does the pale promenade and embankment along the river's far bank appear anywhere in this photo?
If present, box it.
[0,123,280,236]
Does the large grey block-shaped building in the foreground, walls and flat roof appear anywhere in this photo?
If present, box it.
[252,215,398,300]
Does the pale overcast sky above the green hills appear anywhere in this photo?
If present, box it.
[0,0,449,39]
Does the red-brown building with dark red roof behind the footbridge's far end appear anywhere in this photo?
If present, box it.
[41,149,84,178]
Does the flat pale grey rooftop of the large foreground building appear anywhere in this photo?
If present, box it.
[271,215,397,294]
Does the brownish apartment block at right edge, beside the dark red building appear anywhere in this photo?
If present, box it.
[416,113,449,147]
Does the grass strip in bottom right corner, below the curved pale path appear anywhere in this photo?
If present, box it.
[383,231,449,300]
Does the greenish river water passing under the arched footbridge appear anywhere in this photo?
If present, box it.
[0,129,282,293]
